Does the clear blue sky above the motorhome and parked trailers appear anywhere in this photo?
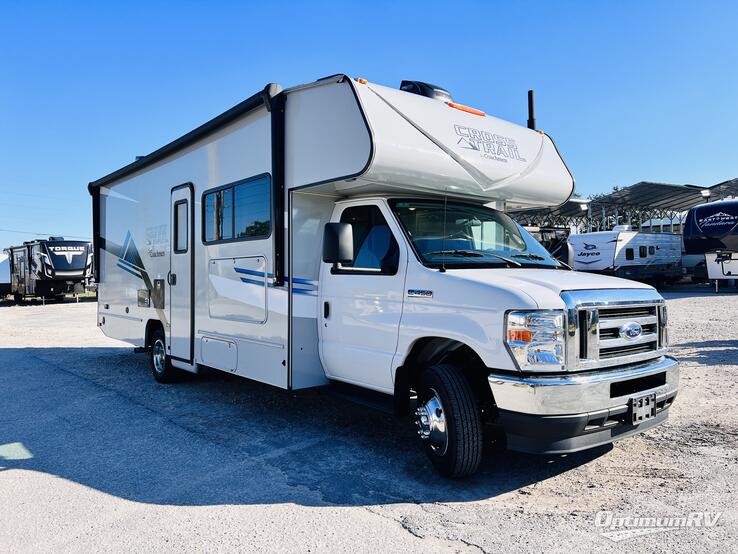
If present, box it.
[0,0,738,248]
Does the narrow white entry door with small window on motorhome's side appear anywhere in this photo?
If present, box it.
[167,184,195,364]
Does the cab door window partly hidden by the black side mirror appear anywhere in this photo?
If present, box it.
[339,206,400,275]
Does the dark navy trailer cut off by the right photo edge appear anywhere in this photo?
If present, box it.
[684,200,738,286]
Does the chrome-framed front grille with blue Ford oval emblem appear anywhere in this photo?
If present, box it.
[561,289,667,370]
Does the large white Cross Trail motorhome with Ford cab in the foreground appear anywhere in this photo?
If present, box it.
[89,75,679,477]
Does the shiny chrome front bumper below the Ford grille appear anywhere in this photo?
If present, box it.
[488,356,679,416]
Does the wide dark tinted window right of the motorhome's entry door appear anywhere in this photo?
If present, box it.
[202,175,272,244]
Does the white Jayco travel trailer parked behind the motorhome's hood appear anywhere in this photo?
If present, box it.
[568,226,682,285]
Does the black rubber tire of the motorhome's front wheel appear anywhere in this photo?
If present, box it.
[417,364,484,478]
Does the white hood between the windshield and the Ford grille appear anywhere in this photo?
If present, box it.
[446,268,653,309]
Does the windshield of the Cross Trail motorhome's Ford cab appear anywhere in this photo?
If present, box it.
[390,199,560,269]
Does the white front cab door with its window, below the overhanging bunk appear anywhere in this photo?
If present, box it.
[320,202,407,392]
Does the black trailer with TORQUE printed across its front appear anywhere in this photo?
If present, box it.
[5,237,93,302]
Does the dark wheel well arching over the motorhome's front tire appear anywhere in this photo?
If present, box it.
[395,337,494,415]
